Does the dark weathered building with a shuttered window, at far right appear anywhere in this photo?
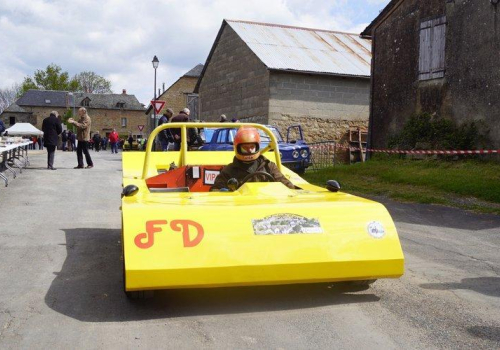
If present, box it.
[362,0,500,148]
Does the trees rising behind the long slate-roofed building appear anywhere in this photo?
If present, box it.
[21,63,78,93]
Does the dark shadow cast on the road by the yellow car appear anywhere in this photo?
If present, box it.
[45,228,379,322]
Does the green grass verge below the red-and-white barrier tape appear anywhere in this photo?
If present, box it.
[304,159,500,214]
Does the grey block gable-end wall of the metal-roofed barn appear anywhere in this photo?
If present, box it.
[199,25,269,121]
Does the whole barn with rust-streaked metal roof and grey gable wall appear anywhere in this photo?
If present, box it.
[195,20,371,141]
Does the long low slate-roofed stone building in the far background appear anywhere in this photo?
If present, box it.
[0,90,147,136]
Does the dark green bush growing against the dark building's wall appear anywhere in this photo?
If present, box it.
[388,113,484,150]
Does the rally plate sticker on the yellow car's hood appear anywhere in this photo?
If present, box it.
[252,214,323,235]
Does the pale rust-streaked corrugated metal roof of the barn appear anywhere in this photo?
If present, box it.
[227,20,371,77]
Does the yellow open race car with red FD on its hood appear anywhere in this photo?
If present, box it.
[122,123,404,298]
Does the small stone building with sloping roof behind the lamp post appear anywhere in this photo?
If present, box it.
[146,64,203,130]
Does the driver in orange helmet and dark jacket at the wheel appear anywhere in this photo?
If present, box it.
[211,127,296,190]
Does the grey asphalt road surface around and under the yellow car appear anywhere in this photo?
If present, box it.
[0,151,500,349]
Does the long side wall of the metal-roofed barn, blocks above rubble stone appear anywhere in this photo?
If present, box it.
[269,72,370,142]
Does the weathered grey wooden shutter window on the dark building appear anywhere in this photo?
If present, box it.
[418,16,446,80]
